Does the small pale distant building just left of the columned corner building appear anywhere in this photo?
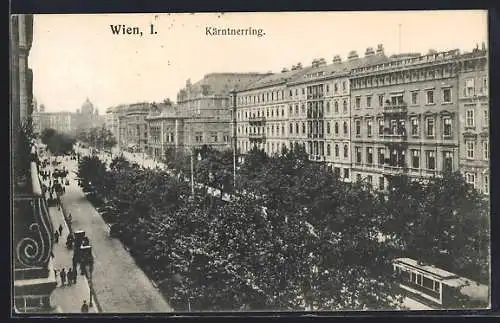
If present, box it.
[118,102,150,152]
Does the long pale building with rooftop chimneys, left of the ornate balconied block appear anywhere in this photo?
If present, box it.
[236,45,394,180]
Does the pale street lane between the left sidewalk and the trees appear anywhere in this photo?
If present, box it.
[58,157,172,313]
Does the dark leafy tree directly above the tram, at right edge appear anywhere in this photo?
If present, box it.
[383,172,489,283]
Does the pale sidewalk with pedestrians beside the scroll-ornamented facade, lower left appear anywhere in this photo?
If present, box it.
[49,206,98,313]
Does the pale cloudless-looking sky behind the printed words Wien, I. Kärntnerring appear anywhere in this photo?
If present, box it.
[29,11,488,114]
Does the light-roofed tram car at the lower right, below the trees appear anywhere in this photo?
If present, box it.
[393,258,489,309]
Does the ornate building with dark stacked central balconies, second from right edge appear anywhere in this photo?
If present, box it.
[351,50,459,189]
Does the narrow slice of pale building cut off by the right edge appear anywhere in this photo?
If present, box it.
[456,45,490,194]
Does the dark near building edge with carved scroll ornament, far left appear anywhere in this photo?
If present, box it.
[9,15,57,313]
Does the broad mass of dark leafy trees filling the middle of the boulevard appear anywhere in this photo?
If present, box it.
[74,147,489,311]
